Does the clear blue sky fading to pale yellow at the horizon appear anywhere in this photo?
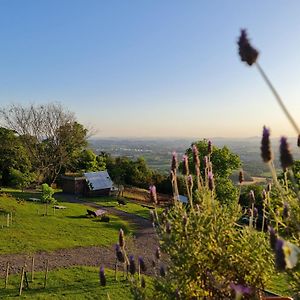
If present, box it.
[0,0,300,137]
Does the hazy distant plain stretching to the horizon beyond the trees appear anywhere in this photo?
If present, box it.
[89,137,300,176]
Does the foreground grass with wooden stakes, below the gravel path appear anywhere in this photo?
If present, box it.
[0,267,140,300]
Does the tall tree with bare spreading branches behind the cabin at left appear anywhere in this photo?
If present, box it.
[0,103,87,183]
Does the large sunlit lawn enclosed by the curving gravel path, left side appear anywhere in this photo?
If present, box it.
[0,194,130,254]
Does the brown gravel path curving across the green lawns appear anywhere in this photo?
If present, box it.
[0,195,158,277]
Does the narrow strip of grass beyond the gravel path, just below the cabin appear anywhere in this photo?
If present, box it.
[80,197,162,219]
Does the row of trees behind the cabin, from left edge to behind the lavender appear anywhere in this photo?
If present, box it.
[0,103,245,202]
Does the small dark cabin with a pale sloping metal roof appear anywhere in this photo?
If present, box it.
[61,171,113,197]
